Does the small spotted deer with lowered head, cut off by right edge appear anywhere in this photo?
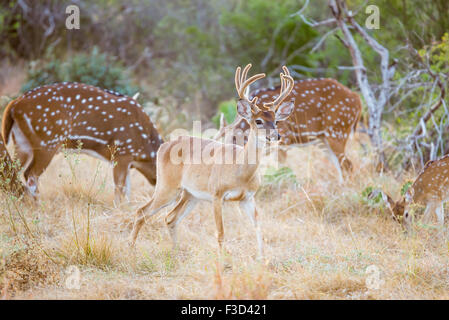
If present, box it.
[369,155,449,231]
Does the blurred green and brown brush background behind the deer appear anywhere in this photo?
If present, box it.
[0,0,449,168]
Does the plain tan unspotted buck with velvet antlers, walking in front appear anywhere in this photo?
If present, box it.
[131,64,294,257]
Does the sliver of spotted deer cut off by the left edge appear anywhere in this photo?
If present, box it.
[0,136,25,197]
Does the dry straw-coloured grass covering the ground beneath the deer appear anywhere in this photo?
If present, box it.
[0,134,449,299]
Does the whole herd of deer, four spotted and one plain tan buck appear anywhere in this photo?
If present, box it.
[0,64,449,257]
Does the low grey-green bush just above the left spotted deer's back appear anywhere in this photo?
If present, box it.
[22,47,141,96]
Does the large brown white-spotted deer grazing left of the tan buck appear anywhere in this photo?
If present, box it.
[2,82,163,201]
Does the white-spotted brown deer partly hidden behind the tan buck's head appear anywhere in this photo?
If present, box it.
[215,67,362,181]
